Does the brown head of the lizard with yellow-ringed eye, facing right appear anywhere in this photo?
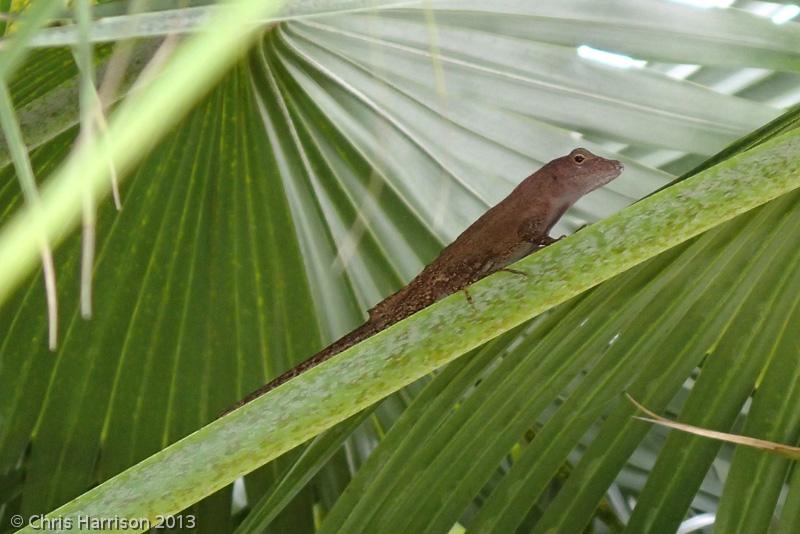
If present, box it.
[548,148,625,198]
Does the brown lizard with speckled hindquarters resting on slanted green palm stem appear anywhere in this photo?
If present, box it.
[225,148,623,413]
